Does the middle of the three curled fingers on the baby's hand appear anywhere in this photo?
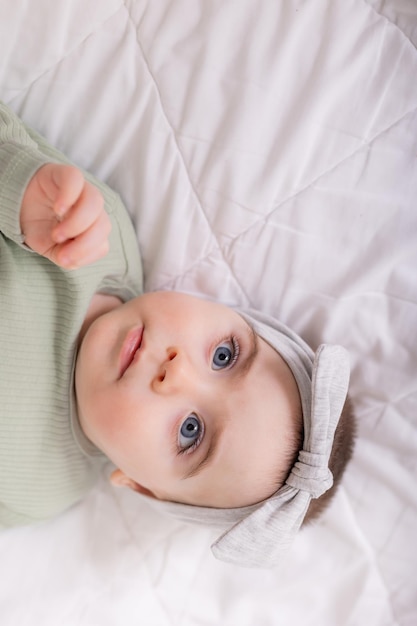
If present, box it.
[53,183,105,243]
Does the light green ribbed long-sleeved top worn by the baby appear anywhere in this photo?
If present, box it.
[0,104,142,527]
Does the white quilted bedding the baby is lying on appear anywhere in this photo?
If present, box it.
[0,0,417,626]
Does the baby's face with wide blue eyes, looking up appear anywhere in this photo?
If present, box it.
[75,292,299,507]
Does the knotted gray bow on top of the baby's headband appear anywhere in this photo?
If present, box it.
[212,345,349,567]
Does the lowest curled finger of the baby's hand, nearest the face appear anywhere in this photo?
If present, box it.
[54,213,111,269]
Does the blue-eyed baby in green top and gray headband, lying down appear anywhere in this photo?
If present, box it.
[0,105,353,566]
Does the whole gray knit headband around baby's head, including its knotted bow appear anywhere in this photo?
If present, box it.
[143,310,349,567]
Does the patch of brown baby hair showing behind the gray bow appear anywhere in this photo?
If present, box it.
[303,397,356,525]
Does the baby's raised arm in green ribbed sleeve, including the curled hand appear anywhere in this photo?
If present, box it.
[0,103,110,269]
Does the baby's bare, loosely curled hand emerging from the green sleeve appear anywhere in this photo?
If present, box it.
[20,163,111,269]
